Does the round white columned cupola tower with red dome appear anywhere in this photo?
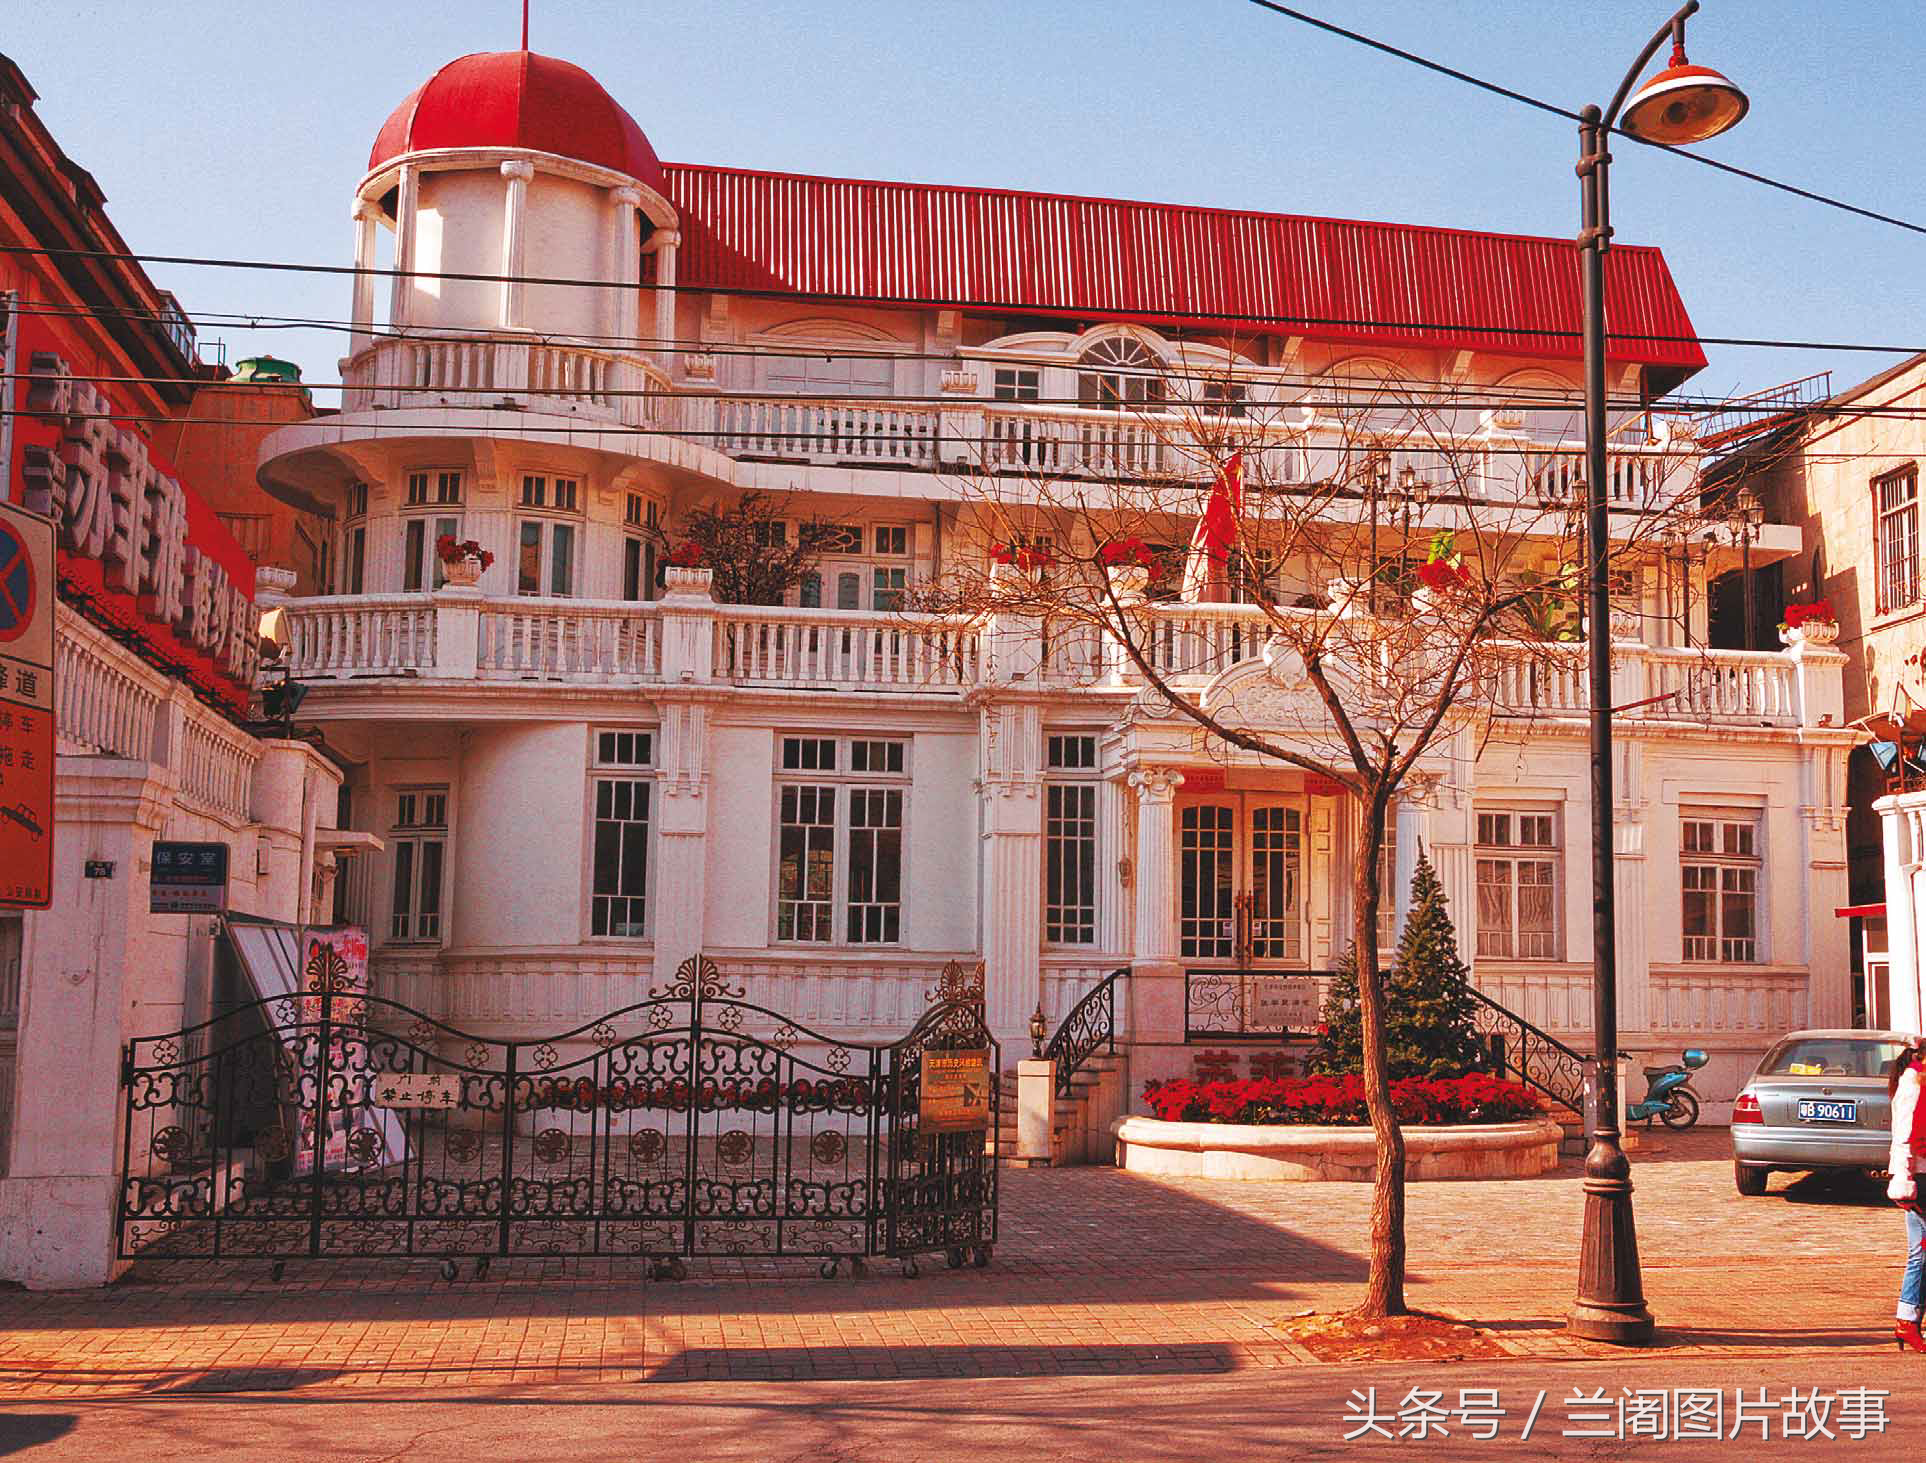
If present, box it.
[354,50,678,352]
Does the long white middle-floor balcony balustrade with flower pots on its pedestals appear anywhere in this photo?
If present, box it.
[271,570,1839,728]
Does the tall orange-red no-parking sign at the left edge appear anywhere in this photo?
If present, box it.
[0,502,54,909]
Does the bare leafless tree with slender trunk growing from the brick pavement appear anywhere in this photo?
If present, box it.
[917,359,1699,1317]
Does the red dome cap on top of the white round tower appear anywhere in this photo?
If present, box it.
[368,50,663,189]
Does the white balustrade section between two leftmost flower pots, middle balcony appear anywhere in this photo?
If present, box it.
[476,599,663,681]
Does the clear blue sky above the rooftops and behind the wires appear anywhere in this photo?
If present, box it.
[0,0,1926,406]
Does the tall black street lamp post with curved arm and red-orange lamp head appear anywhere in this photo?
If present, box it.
[1568,0,1747,1344]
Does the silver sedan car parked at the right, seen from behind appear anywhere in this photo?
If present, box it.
[1731,1032,1911,1194]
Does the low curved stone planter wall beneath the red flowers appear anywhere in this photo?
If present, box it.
[1111,1117,1564,1184]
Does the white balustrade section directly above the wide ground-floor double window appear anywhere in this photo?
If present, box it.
[715,604,978,691]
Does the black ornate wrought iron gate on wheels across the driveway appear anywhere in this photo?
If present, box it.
[117,957,1000,1271]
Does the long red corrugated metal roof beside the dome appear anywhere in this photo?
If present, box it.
[663,164,1705,391]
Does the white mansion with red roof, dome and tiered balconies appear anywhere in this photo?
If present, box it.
[260,52,1853,1115]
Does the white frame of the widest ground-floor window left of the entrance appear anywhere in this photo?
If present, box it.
[768,730,915,949]
